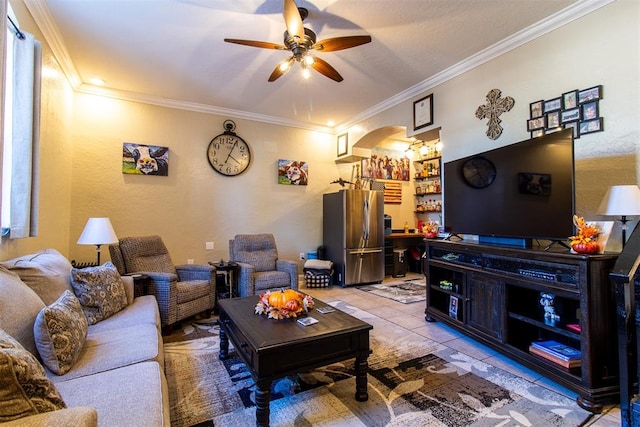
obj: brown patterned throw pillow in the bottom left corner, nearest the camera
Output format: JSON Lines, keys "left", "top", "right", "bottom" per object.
{"left": 0, "top": 329, "right": 66, "bottom": 422}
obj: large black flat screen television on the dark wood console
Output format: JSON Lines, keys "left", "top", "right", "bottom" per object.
{"left": 443, "top": 129, "right": 575, "bottom": 246}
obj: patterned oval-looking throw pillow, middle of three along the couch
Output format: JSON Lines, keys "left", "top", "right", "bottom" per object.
{"left": 33, "top": 291, "right": 88, "bottom": 375}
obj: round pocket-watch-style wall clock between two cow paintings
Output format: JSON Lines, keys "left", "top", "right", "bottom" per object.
{"left": 207, "top": 120, "right": 251, "bottom": 176}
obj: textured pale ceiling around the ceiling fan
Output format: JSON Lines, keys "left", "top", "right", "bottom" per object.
{"left": 18, "top": 0, "right": 581, "bottom": 129}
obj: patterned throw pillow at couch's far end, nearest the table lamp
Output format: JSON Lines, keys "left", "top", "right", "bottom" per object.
{"left": 71, "top": 262, "right": 127, "bottom": 325}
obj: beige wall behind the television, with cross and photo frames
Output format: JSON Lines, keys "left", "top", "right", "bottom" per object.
{"left": 342, "top": 0, "right": 640, "bottom": 249}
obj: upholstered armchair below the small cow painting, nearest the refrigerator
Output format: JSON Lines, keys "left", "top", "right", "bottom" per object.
{"left": 229, "top": 234, "right": 298, "bottom": 296}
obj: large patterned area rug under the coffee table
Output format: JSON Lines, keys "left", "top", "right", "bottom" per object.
{"left": 165, "top": 301, "right": 589, "bottom": 427}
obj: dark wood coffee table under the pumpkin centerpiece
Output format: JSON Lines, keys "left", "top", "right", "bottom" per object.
{"left": 218, "top": 296, "right": 373, "bottom": 426}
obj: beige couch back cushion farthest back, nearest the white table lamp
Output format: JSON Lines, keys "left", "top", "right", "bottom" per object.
{"left": 2, "top": 249, "right": 71, "bottom": 305}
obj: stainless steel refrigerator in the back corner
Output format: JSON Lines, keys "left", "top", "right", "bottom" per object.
{"left": 322, "top": 190, "right": 384, "bottom": 286}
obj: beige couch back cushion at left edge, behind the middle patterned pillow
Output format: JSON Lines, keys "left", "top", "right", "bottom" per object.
{"left": 0, "top": 265, "right": 44, "bottom": 355}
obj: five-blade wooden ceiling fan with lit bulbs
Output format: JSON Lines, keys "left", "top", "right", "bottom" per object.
{"left": 224, "top": 0, "right": 371, "bottom": 82}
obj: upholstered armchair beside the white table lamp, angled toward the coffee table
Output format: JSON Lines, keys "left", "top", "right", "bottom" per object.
{"left": 109, "top": 236, "right": 216, "bottom": 327}
